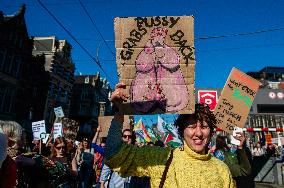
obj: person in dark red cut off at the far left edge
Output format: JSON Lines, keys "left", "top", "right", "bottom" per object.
{"left": 0, "top": 128, "right": 17, "bottom": 188}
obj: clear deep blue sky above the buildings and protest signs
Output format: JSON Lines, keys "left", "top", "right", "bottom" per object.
{"left": 0, "top": 0, "right": 284, "bottom": 88}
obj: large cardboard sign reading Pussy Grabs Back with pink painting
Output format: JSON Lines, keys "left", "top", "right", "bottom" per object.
{"left": 114, "top": 16, "right": 195, "bottom": 114}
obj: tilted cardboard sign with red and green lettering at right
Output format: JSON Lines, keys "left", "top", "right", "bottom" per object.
{"left": 214, "top": 68, "right": 260, "bottom": 134}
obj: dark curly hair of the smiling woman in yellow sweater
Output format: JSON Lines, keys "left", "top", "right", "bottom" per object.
{"left": 175, "top": 103, "right": 216, "bottom": 138}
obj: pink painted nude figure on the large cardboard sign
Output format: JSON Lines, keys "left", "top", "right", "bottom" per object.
{"left": 130, "top": 27, "right": 189, "bottom": 113}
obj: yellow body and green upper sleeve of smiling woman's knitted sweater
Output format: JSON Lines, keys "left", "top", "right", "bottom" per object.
{"left": 105, "top": 144, "right": 235, "bottom": 188}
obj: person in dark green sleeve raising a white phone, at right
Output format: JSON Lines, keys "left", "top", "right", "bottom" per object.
{"left": 214, "top": 133, "right": 253, "bottom": 188}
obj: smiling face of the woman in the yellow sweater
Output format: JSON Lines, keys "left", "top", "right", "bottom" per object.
{"left": 184, "top": 121, "right": 211, "bottom": 154}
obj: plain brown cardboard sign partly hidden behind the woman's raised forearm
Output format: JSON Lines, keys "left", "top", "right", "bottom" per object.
{"left": 99, "top": 116, "right": 133, "bottom": 138}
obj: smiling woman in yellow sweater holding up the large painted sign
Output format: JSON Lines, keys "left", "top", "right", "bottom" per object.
{"left": 105, "top": 83, "right": 235, "bottom": 188}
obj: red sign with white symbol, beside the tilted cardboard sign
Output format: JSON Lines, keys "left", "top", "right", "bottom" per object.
{"left": 198, "top": 90, "right": 218, "bottom": 111}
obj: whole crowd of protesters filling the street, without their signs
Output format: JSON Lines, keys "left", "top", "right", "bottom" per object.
{"left": 0, "top": 84, "right": 284, "bottom": 188}
